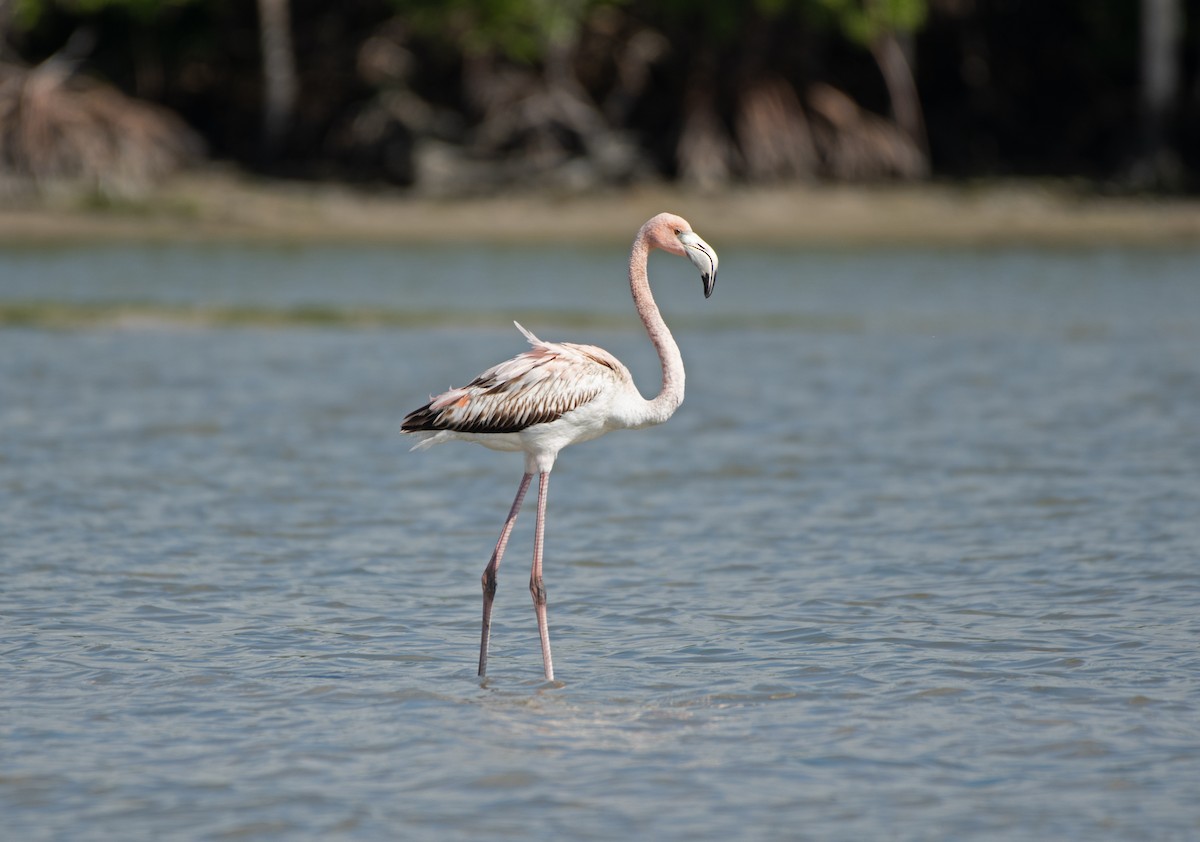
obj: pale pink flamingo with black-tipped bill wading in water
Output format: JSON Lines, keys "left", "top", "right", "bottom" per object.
{"left": 401, "top": 213, "right": 716, "bottom": 681}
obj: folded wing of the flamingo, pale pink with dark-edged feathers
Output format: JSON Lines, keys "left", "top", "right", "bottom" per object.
{"left": 401, "top": 323, "right": 629, "bottom": 433}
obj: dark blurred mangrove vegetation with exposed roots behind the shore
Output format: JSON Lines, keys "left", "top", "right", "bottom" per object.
{"left": 0, "top": 0, "right": 1200, "bottom": 194}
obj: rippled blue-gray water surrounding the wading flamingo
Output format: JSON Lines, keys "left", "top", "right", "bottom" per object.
{"left": 0, "top": 242, "right": 1200, "bottom": 841}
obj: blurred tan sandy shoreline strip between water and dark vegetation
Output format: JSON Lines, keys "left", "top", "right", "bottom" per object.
{"left": 0, "top": 170, "right": 1200, "bottom": 248}
